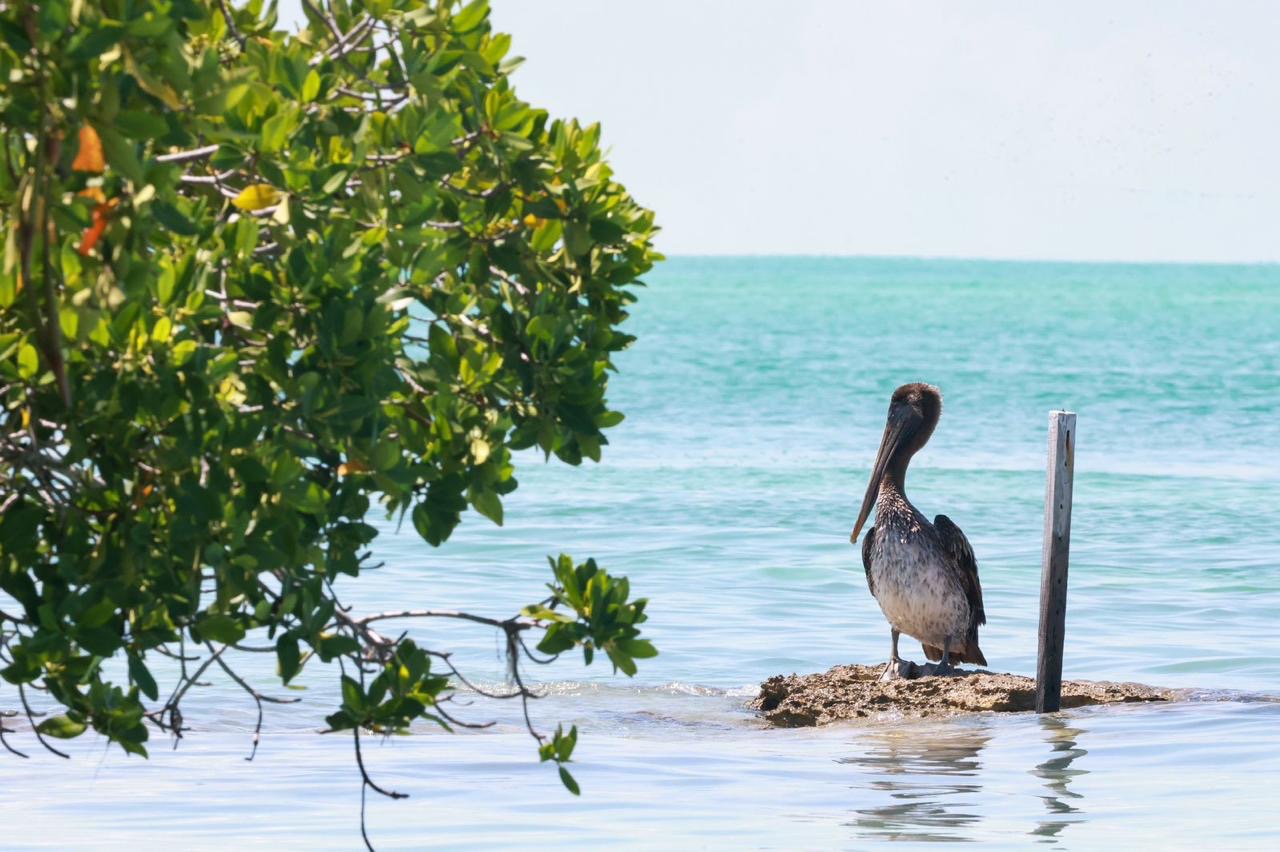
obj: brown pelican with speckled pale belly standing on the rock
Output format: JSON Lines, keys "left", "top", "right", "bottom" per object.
{"left": 849, "top": 383, "right": 987, "bottom": 679}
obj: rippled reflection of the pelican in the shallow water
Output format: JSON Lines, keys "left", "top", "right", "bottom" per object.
{"left": 840, "top": 725, "right": 991, "bottom": 842}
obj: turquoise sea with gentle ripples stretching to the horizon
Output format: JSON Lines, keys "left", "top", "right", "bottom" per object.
{"left": 0, "top": 257, "right": 1280, "bottom": 849}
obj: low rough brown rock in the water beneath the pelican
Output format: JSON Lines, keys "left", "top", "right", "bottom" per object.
{"left": 751, "top": 664, "right": 1174, "bottom": 728}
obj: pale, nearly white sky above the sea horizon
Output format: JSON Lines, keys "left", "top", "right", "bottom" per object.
{"left": 285, "top": 0, "right": 1280, "bottom": 261}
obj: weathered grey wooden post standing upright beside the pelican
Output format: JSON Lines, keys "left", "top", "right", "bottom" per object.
{"left": 1036, "top": 411, "right": 1075, "bottom": 713}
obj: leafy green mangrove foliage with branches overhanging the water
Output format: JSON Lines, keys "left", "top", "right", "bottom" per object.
{"left": 0, "top": 0, "right": 659, "bottom": 808}
